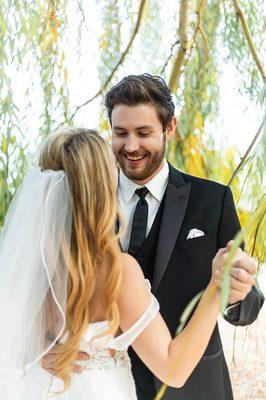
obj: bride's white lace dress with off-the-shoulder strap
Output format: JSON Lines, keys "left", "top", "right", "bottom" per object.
{"left": 44, "top": 281, "right": 159, "bottom": 400}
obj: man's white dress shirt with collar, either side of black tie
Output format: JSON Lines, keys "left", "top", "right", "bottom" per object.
{"left": 118, "top": 161, "right": 169, "bottom": 251}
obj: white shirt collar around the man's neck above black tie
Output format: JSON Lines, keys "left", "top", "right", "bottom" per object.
{"left": 119, "top": 160, "right": 169, "bottom": 204}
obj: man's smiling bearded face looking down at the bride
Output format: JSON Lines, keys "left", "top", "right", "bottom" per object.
{"left": 112, "top": 103, "right": 172, "bottom": 185}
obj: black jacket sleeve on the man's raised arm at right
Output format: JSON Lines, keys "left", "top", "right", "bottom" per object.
{"left": 217, "top": 187, "right": 264, "bottom": 326}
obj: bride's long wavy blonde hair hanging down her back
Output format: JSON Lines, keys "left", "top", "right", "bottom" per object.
{"left": 40, "top": 128, "right": 121, "bottom": 388}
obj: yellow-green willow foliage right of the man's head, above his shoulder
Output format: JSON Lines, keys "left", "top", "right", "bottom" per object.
{"left": 165, "top": 1, "right": 266, "bottom": 270}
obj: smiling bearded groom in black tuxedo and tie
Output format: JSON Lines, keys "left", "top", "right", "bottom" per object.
{"left": 106, "top": 74, "right": 264, "bottom": 400}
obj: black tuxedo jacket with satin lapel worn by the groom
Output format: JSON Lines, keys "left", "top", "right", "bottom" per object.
{"left": 131, "top": 165, "right": 264, "bottom": 400}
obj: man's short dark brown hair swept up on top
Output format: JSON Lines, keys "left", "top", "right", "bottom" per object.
{"left": 105, "top": 74, "right": 175, "bottom": 131}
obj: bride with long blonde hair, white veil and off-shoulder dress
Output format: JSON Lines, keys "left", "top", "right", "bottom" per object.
{"left": 0, "top": 129, "right": 235, "bottom": 400}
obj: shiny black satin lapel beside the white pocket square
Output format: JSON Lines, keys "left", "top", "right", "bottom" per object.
{"left": 152, "top": 167, "right": 191, "bottom": 293}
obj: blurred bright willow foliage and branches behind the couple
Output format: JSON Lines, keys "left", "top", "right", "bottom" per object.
{"left": 0, "top": 0, "right": 266, "bottom": 267}
